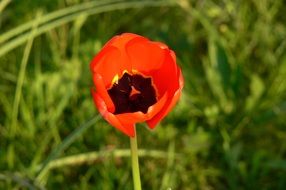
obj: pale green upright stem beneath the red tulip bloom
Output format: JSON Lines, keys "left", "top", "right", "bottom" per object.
{"left": 130, "top": 129, "right": 141, "bottom": 190}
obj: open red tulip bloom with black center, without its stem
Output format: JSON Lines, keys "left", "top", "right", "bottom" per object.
{"left": 90, "top": 33, "right": 184, "bottom": 137}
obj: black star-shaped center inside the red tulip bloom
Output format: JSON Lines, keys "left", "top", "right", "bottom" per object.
{"left": 108, "top": 73, "right": 157, "bottom": 114}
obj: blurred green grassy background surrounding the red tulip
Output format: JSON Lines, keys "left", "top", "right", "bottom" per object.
{"left": 0, "top": 0, "right": 286, "bottom": 190}
